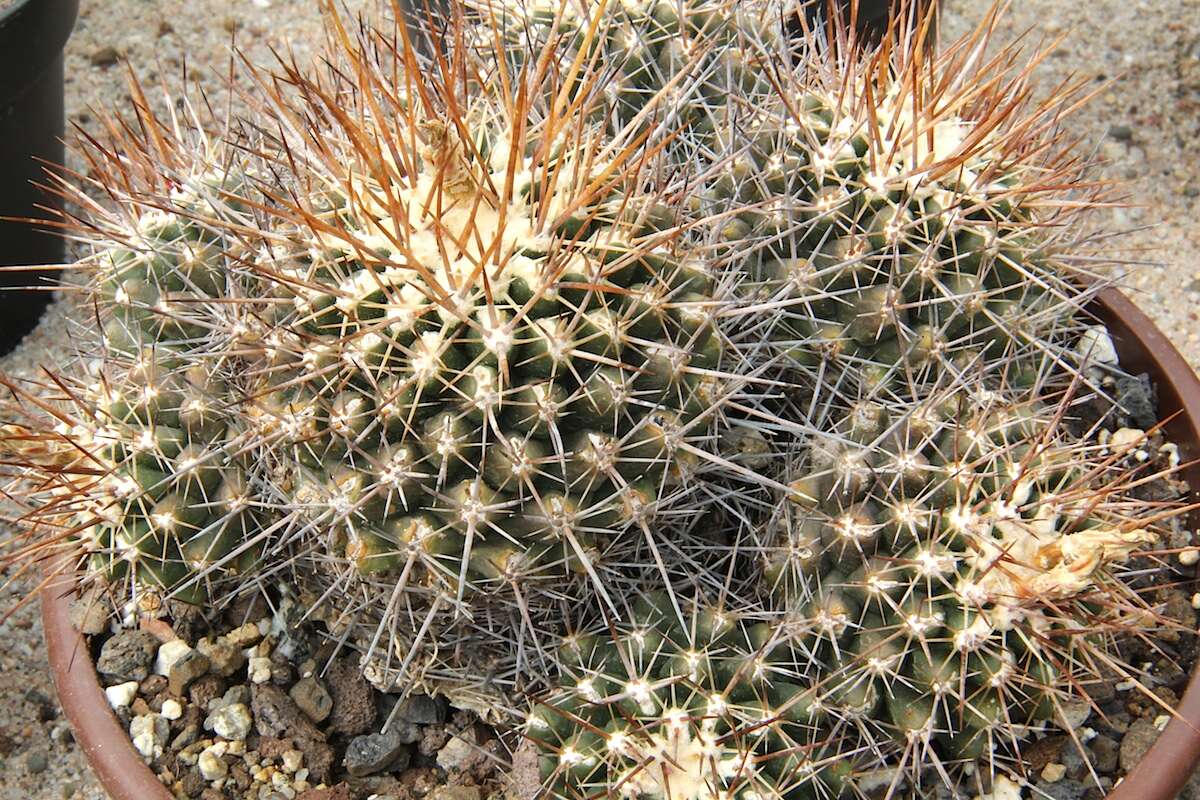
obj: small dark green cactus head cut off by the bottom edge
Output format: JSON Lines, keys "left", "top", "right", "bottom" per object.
{"left": 526, "top": 595, "right": 845, "bottom": 800}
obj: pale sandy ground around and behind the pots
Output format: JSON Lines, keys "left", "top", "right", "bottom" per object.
{"left": 0, "top": 0, "right": 1200, "bottom": 800}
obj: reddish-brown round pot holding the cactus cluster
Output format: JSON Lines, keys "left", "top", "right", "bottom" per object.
{"left": 42, "top": 289, "right": 1200, "bottom": 800}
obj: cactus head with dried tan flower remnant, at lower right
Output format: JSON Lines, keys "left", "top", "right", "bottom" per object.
{"left": 760, "top": 390, "right": 1156, "bottom": 786}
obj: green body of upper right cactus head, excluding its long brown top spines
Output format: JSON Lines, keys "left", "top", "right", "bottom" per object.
{"left": 708, "top": 83, "right": 1094, "bottom": 391}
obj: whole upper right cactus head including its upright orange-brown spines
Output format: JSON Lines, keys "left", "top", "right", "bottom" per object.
{"left": 708, "top": 7, "right": 1103, "bottom": 393}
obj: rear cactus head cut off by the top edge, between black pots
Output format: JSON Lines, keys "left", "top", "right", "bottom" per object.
{"left": 470, "top": 0, "right": 786, "bottom": 146}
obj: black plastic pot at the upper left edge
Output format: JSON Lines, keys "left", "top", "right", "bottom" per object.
{"left": 0, "top": 0, "right": 79, "bottom": 354}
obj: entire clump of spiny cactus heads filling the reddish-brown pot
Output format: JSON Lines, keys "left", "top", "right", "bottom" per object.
{"left": 6, "top": 0, "right": 1170, "bottom": 800}
